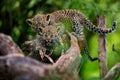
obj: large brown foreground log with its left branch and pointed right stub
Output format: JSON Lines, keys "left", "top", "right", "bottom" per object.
{"left": 0, "top": 34, "right": 81, "bottom": 80}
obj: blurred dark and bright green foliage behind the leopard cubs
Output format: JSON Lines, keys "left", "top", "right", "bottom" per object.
{"left": 0, "top": 0, "right": 120, "bottom": 80}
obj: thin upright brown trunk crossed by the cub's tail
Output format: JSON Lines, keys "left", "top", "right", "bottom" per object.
{"left": 98, "top": 16, "right": 108, "bottom": 79}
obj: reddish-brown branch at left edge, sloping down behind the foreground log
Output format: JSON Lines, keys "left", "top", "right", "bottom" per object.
{"left": 0, "top": 33, "right": 23, "bottom": 56}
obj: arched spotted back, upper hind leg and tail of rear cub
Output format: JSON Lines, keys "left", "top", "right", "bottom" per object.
{"left": 51, "top": 10, "right": 117, "bottom": 34}
